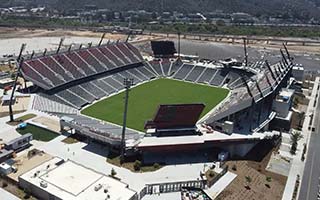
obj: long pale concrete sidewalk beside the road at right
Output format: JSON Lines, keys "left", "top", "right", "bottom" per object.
{"left": 282, "top": 77, "right": 320, "bottom": 200}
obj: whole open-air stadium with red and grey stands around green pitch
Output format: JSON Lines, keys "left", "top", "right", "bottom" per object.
{"left": 18, "top": 38, "right": 293, "bottom": 163}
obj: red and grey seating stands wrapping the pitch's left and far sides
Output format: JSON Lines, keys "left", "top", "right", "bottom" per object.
{"left": 25, "top": 40, "right": 272, "bottom": 114}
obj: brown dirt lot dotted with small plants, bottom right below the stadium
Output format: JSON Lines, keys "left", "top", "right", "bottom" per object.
{"left": 217, "top": 141, "right": 287, "bottom": 200}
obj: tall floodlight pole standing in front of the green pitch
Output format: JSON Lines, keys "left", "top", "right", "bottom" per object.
{"left": 120, "top": 78, "right": 133, "bottom": 164}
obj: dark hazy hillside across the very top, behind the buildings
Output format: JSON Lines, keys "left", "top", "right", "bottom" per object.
{"left": 0, "top": 0, "right": 320, "bottom": 18}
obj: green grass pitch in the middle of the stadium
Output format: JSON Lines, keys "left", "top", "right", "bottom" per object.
{"left": 81, "top": 79, "right": 229, "bottom": 131}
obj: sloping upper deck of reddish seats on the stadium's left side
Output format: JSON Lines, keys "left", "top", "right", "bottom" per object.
{"left": 21, "top": 43, "right": 143, "bottom": 90}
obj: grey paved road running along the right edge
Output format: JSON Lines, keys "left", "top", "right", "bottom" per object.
{"left": 299, "top": 93, "right": 320, "bottom": 200}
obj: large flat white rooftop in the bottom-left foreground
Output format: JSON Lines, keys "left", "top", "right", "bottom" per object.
{"left": 20, "top": 157, "right": 136, "bottom": 200}
